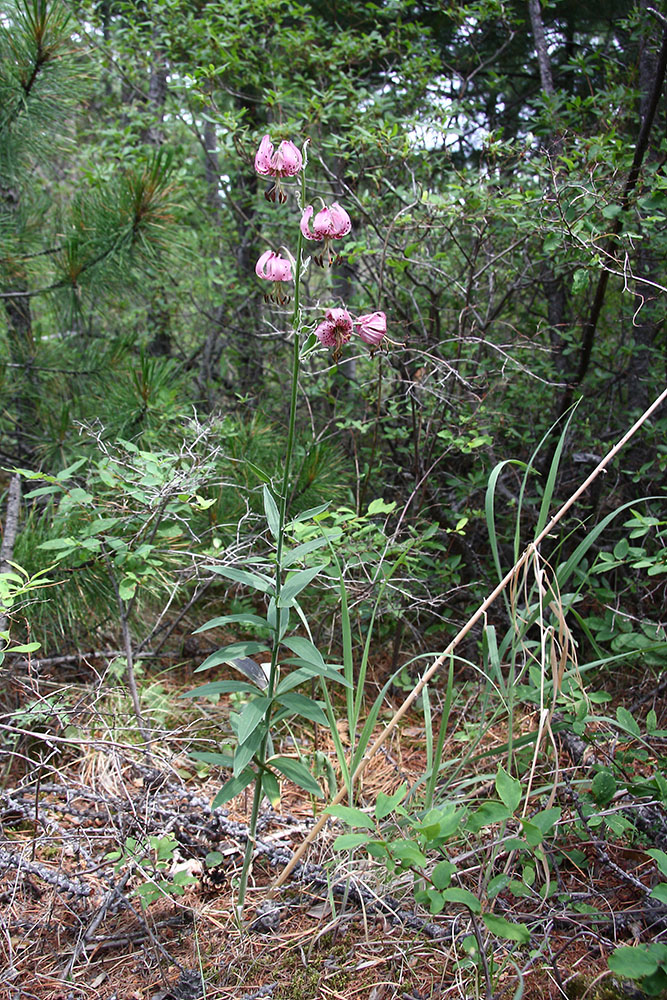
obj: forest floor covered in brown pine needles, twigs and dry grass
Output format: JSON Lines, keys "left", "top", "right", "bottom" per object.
{"left": 0, "top": 648, "right": 667, "bottom": 1000}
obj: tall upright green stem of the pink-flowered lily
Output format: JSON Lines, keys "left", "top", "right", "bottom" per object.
{"left": 236, "top": 171, "right": 306, "bottom": 920}
